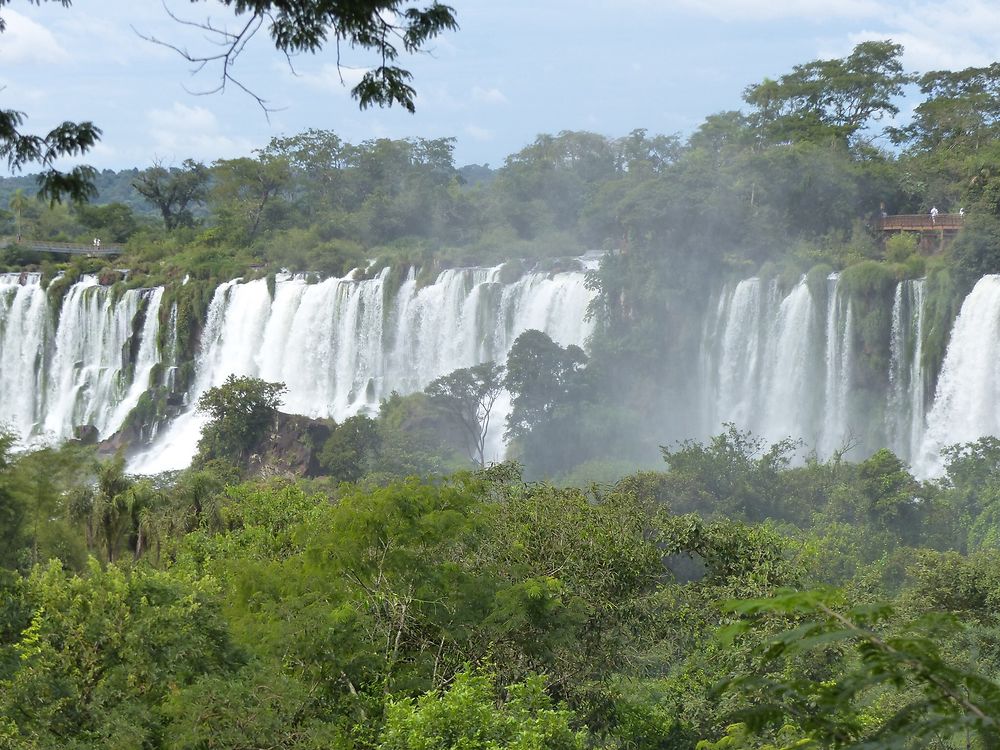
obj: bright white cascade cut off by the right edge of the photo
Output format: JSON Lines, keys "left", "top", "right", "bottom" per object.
{"left": 915, "top": 275, "right": 1000, "bottom": 476}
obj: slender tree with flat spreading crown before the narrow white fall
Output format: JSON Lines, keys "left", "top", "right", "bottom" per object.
{"left": 424, "top": 362, "right": 504, "bottom": 468}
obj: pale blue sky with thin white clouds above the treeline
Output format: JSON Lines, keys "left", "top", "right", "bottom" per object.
{"left": 0, "top": 0, "right": 1000, "bottom": 174}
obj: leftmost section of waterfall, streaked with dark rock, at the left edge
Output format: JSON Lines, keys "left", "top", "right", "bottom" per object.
{"left": 0, "top": 274, "right": 163, "bottom": 443}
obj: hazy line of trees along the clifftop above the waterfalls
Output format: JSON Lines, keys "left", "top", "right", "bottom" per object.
{"left": 0, "top": 41, "right": 1000, "bottom": 286}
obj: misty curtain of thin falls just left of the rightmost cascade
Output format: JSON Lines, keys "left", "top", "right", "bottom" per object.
{"left": 701, "top": 274, "right": 925, "bottom": 460}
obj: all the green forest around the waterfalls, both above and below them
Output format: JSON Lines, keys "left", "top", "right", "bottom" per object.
{"left": 0, "top": 41, "right": 1000, "bottom": 750}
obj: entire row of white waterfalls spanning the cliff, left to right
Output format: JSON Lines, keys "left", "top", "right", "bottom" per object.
{"left": 0, "top": 260, "right": 976, "bottom": 476}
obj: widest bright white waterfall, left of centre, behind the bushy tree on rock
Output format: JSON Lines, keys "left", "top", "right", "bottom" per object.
{"left": 132, "top": 266, "right": 591, "bottom": 473}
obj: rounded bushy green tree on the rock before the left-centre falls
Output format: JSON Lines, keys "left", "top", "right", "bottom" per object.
{"left": 198, "top": 375, "right": 286, "bottom": 463}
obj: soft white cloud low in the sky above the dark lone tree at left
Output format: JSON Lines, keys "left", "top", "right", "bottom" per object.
{"left": 146, "top": 102, "right": 258, "bottom": 164}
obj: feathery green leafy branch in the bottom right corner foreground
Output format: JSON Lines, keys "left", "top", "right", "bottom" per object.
{"left": 717, "top": 590, "right": 1000, "bottom": 750}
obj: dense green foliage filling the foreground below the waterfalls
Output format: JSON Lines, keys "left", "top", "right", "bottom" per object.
{"left": 9, "top": 432, "right": 1000, "bottom": 750}
